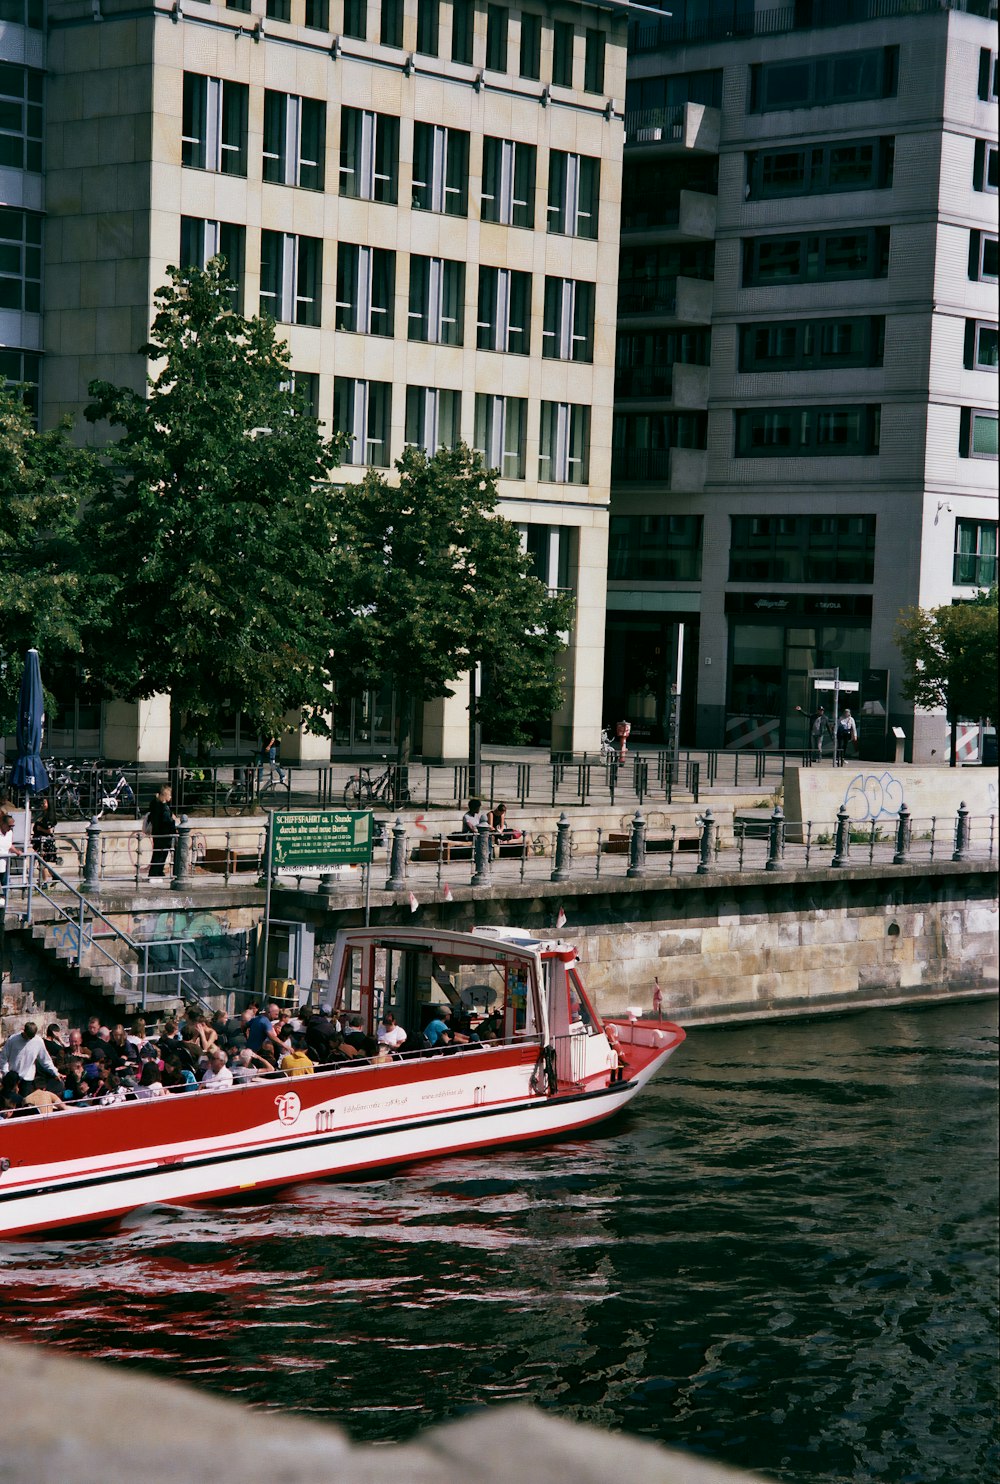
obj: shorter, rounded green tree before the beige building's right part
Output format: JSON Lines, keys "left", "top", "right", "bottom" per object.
{"left": 329, "top": 445, "right": 573, "bottom": 760}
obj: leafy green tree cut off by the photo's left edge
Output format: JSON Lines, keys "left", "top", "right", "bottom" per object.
{"left": 0, "top": 387, "right": 108, "bottom": 732}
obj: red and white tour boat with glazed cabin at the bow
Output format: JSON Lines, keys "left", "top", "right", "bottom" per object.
{"left": 0, "top": 928, "right": 684, "bottom": 1236}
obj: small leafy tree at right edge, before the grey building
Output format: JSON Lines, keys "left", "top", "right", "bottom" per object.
{"left": 895, "top": 588, "right": 997, "bottom": 767}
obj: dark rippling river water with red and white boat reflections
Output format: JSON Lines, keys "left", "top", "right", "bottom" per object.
{"left": 0, "top": 1002, "right": 1000, "bottom": 1484}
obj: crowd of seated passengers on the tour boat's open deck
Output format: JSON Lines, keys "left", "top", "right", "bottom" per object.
{"left": 0, "top": 1003, "right": 504, "bottom": 1117}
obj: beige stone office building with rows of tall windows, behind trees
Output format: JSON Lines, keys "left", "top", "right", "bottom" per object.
{"left": 0, "top": 0, "right": 628, "bottom": 761}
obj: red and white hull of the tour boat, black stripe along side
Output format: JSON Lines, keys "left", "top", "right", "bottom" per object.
{"left": 0, "top": 1022, "right": 684, "bottom": 1236}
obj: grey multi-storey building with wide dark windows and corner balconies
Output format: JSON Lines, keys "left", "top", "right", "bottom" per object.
{"left": 605, "top": 0, "right": 997, "bottom": 760}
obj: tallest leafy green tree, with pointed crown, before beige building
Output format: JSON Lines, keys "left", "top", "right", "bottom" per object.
{"left": 86, "top": 258, "right": 341, "bottom": 763}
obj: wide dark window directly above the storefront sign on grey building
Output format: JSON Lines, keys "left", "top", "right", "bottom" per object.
{"left": 728, "top": 515, "right": 875, "bottom": 583}
